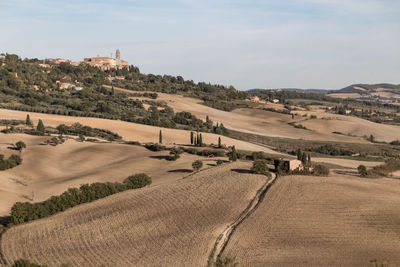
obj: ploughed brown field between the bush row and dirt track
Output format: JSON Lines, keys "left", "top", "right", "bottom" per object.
{"left": 0, "top": 162, "right": 266, "bottom": 266}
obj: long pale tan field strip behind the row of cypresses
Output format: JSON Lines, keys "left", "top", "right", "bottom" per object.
{"left": 0, "top": 109, "right": 279, "bottom": 154}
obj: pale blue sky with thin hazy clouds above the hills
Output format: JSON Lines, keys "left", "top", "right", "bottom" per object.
{"left": 0, "top": 0, "right": 400, "bottom": 90}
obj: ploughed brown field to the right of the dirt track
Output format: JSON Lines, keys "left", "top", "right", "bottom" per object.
{"left": 223, "top": 175, "right": 400, "bottom": 266}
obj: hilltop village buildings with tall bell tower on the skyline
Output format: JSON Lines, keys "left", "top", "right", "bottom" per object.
{"left": 52, "top": 49, "right": 129, "bottom": 70}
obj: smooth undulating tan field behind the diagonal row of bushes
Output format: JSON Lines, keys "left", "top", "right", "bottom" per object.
{"left": 0, "top": 134, "right": 220, "bottom": 216}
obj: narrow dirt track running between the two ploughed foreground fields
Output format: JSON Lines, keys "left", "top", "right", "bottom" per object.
{"left": 207, "top": 174, "right": 278, "bottom": 267}
